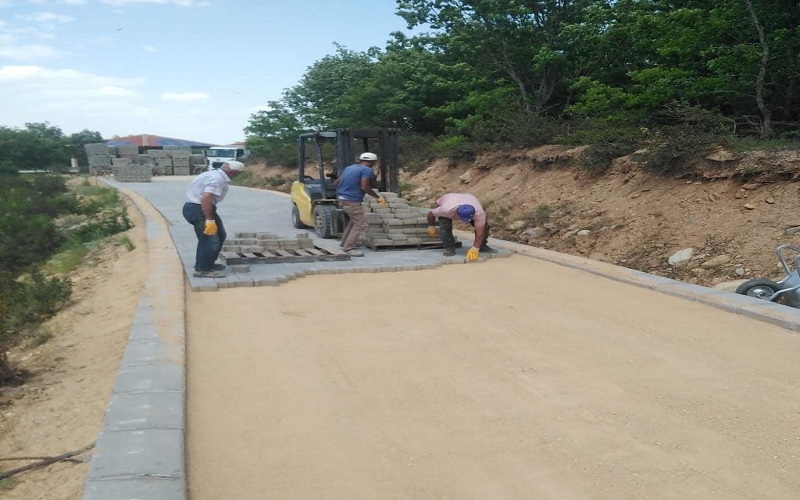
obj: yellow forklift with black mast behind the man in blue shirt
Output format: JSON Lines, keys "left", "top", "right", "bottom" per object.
{"left": 292, "top": 128, "right": 400, "bottom": 238}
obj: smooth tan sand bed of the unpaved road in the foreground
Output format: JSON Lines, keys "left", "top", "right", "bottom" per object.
{"left": 187, "top": 256, "right": 800, "bottom": 500}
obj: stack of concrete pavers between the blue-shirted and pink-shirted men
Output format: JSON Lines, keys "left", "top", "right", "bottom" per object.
{"left": 363, "top": 193, "right": 441, "bottom": 250}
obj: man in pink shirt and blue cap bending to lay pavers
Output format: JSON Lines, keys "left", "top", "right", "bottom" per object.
{"left": 427, "top": 193, "right": 496, "bottom": 260}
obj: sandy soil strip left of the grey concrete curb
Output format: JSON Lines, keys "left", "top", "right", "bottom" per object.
{"left": 0, "top": 193, "right": 148, "bottom": 500}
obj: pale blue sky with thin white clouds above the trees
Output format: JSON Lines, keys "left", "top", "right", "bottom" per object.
{"left": 0, "top": 0, "right": 406, "bottom": 144}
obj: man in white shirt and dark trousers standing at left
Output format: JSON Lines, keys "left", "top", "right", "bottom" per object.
{"left": 183, "top": 161, "right": 245, "bottom": 278}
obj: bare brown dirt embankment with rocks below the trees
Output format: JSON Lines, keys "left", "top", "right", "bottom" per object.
{"left": 247, "top": 146, "right": 800, "bottom": 286}
